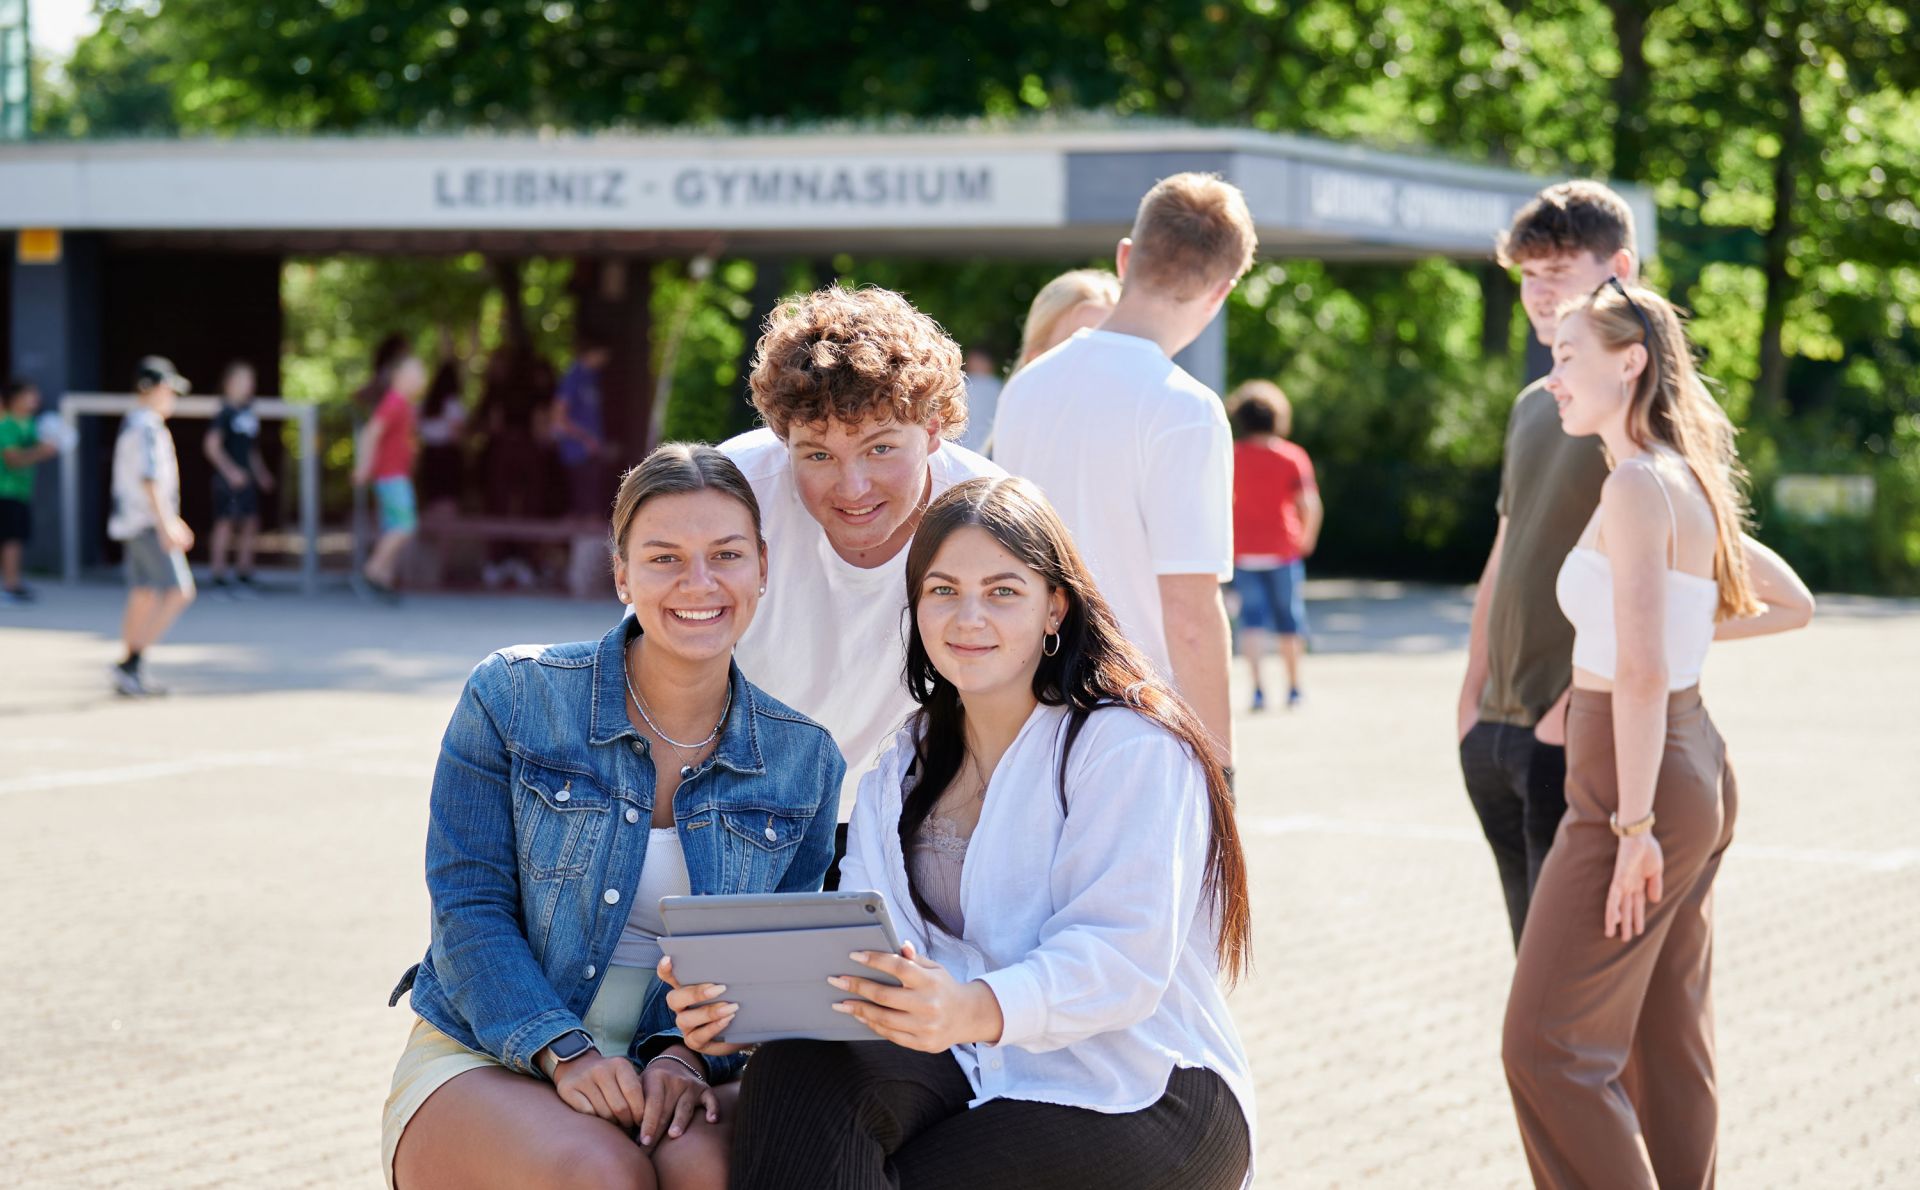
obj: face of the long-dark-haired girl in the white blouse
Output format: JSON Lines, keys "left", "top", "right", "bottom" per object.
{"left": 914, "top": 526, "right": 1068, "bottom": 699}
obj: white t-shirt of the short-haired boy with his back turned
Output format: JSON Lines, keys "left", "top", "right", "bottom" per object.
{"left": 993, "top": 330, "right": 1233, "bottom": 679}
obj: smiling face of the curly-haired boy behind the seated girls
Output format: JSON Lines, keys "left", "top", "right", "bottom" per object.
{"left": 787, "top": 417, "right": 941, "bottom": 566}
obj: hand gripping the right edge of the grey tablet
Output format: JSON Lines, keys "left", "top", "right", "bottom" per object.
{"left": 828, "top": 942, "right": 1004, "bottom": 1054}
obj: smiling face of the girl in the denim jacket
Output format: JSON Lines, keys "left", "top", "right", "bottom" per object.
{"left": 614, "top": 489, "right": 766, "bottom": 660}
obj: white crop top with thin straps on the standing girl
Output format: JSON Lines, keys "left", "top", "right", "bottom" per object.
{"left": 1553, "top": 466, "right": 1720, "bottom": 691}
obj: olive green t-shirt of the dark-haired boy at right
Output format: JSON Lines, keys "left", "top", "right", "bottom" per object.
{"left": 1480, "top": 382, "right": 1607, "bottom": 727}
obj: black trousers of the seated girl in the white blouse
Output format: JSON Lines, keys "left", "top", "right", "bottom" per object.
{"left": 730, "top": 1040, "right": 1250, "bottom": 1190}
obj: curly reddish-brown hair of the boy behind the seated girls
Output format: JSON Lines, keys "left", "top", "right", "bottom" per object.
{"left": 749, "top": 284, "right": 966, "bottom": 441}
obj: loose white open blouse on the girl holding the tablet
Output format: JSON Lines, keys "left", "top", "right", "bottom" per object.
{"left": 839, "top": 706, "right": 1258, "bottom": 1174}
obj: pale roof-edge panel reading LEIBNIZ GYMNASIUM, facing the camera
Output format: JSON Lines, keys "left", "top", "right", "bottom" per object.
{"left": 0, "top": 144, "right": 1066, "bottom": 230}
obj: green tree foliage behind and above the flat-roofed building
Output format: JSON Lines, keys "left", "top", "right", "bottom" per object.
{"left": 40, "top": 0, "right": 1920, "bottom": 585}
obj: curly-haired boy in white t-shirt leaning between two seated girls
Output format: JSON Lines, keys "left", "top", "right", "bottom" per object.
{"left": 720, "top": 286, "right": 1002, "bottom": 821}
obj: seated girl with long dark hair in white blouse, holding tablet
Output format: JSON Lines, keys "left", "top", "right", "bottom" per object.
{"left": 662, "top": 478, "right": 1254, "bottom": 1190}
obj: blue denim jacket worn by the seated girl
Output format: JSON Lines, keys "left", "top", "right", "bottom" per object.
{"left": 392, "top": 618, "right": 847, "bottom": 1081}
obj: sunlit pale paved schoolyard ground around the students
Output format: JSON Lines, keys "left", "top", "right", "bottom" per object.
{"left": 0, "top": 585, "right": 1920, "bottom": 1188}
